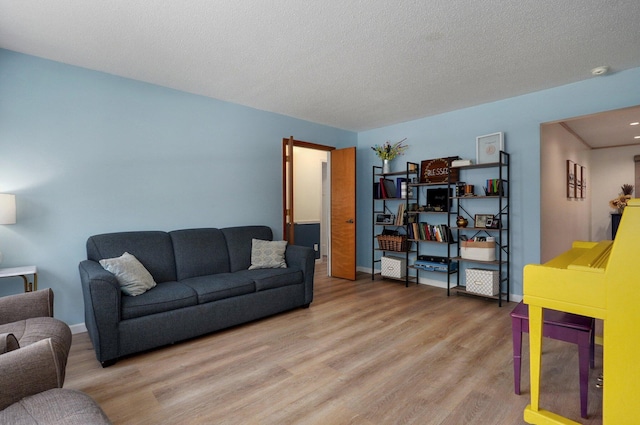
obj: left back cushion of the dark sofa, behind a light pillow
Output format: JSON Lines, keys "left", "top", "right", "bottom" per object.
{"left": 87, "top": 231, "right": 176, "bottom": 283}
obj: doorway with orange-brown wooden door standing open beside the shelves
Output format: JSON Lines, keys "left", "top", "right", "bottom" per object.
{"left": 282, "top": 137, "right": 356, "bottom": 280}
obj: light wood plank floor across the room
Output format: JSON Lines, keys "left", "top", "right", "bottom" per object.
{"left": 65, "top": 266, "right": 602, "bottom": 425}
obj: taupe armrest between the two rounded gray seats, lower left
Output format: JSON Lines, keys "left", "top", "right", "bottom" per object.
{"left": 0, "top": 338, "right": 62, "bottom": 410}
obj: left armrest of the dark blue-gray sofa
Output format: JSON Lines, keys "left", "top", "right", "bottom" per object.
{"left": 78, "top": 260, "right": 122, "bottom": 362}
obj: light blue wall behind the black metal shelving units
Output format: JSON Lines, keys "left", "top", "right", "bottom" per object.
{"left": 358, "top": 68, "right": 640, "bottom": 295}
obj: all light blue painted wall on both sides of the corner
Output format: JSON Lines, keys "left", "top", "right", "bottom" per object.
{"left": 0, "top": 49, "right": 640, "bottom": 324}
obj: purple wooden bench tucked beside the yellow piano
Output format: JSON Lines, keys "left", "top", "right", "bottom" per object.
{"left": 511, "top": 302, "right": 595, "bottom": 418}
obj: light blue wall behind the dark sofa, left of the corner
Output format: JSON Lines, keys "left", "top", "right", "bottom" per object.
{"left": 0, "top": 50, "right": 357, "bottom": 324}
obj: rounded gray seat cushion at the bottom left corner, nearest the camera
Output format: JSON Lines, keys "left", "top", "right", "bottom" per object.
{"left": 0, "top": 388, "right": 111, "bottom": 425}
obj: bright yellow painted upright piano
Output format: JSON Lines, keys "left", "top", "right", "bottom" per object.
{"left": 524, "top": 199, "right": 640, "bottom": 425}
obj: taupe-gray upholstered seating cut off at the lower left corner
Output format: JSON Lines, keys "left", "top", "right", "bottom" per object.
{"left": 0, "top": 289, "right": 111, "bottom": 425}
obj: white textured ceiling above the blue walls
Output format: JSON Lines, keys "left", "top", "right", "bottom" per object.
{"left": 0, "top": 0, "right": 640, "bottom": 131}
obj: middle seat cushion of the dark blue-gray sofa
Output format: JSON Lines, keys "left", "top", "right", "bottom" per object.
{"left": 181, "top": 273, "right": 256, "bottom": 304}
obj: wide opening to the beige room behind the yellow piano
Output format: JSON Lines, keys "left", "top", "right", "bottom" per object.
{"left": 540, "top": 106, "right": 640, "bottom": 262}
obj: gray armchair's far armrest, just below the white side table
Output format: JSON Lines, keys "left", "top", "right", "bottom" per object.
{"left": 0, "top": 288, "right": 53, "bottom": 325}
